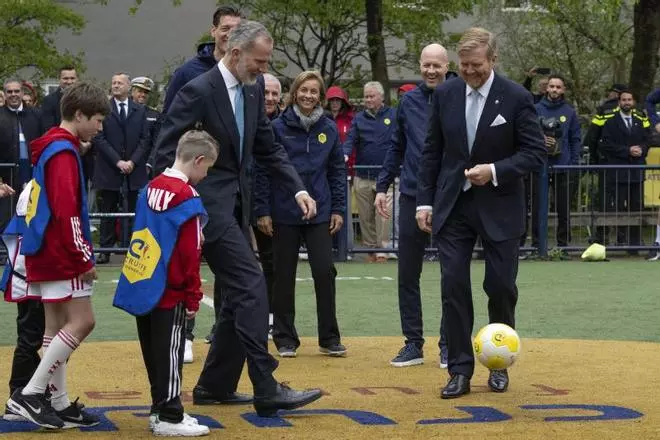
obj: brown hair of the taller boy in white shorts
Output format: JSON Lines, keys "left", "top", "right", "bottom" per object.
{"left": 60, "top": 81, "right": 110, "bottom": 121}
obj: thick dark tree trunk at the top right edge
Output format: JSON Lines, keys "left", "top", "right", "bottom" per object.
{"left": 629, "top": 0, "right": 660, "bottom": 101}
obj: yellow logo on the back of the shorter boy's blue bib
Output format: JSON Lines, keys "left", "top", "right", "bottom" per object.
{"left": 121, "top": 228, "right": 161, "bottom": 284}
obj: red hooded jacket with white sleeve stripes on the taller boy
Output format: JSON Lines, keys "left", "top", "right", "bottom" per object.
{"left": 25, "top": 127, "right": 94, "bottom": 282}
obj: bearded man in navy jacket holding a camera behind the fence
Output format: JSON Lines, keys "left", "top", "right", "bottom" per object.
{"left": 532, "top": 74, "right": 581, "bottom": 254}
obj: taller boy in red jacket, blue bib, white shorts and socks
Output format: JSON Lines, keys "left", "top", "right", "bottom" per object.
{"left": 7, "top": 82, "right": 110, "bottom": 429}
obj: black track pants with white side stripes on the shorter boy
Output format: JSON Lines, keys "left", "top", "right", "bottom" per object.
{"left": 136, "top": 303, "right": 186, "bottom": 423}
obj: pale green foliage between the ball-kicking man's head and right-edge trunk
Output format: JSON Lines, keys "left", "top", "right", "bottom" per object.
{"left": 480, "top": 0, "right": 633, "bottom": 112}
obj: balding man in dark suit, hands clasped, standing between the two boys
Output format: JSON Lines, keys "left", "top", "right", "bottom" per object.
{"left": 93, "top": 73, "right": 149, "bottom": 264}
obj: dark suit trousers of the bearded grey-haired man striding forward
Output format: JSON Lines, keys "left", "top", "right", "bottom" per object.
{"left": 197, "top": 218, "right": 278, "bottom": 395}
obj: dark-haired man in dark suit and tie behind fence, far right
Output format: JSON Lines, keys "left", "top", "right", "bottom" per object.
{"left": 598, "top": 90, "right": 652, "bottom": 249}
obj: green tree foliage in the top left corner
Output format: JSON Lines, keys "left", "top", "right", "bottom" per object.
{"left": 0, "top": 0, "right": 85, "bottom": 78}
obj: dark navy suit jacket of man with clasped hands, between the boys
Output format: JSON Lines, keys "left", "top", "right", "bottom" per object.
{"left": 92, "top": 99, "right": 150, "bottom": 191}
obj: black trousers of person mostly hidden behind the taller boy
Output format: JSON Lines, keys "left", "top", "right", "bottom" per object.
{"left": 9, "top": 299, "right": 45, "bottom": 395}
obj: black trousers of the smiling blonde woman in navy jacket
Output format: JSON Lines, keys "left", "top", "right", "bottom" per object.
{"left": 273, "top": 222, "right": 341, "bottom": 348}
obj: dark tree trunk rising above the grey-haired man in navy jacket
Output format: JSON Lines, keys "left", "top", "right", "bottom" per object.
{"left": 365, "top": 0, "right": 390, "bottom": 105}
